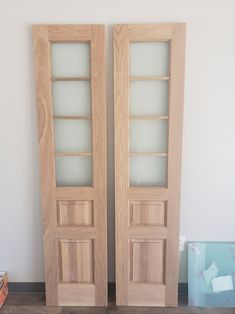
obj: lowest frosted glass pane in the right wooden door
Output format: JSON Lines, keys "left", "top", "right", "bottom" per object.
{"left": 129, "top": 156, "right": 167, "bottom": 186}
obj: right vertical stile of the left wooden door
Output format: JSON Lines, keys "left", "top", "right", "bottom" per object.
{"left": 91, "top": 25, "right": 108, "bottom": 306}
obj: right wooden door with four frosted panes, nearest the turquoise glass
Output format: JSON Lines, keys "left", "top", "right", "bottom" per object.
{"left": 113, "top": 24, "right": 185, "bottom": 306}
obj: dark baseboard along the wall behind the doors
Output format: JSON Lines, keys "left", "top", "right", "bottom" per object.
{"left": 8, "top": 282, "right": 188, "bottom": 295}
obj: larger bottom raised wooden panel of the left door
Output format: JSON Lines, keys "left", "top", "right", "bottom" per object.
{"left": 59, "top": 239, "right": 93, "bottom": 283}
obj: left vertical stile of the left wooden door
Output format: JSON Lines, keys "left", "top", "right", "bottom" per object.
{"left": 33, "top": 26, "right": 58, "bottom": 305}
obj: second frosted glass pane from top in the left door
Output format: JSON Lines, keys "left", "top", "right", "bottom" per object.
{"left": 52, "top": 81, "right": 91, "bottom": 116}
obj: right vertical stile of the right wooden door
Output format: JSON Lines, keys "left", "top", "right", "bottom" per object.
{"left": 166, "top": 24, "right": 186, "bottom": 306}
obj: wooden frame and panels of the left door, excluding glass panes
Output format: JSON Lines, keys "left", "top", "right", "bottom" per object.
{"left": 34, "top": 25, "right": 107, "bottom": 306}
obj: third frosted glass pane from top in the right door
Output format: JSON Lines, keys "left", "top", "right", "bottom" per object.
{"left": 129, "top": 120, "right": 168, "bottom": 153}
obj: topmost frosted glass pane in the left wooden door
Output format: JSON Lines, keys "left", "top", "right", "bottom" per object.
{"left": 51, "top": 43, "right": 90, "bottom": 77}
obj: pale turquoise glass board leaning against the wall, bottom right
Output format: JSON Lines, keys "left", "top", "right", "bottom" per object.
{"left": 188, "top": 242, "right": 235, "bottom": 306}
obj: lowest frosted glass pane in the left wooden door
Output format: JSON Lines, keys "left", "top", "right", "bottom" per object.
{"left": 55, "top": 156, "right": 92, "bottom": 186}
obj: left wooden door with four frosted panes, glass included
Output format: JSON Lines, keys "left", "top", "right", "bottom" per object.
{"left": 33, "top": 25, "right": 107, "bottom": 306}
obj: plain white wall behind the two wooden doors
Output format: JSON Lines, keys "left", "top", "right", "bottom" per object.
{"left": 0, "top": 0, "right": 235, "bottom": 282}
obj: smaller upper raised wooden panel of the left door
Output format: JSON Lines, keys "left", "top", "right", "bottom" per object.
{"left": 57, "top": 201, "right": 93, "bottom": 226}
